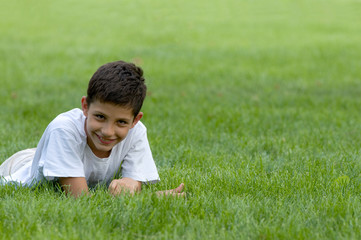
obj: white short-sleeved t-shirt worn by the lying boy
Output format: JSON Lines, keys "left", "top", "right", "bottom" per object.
{"left": 4, "top": 108, "right": 159, "bottom": 187}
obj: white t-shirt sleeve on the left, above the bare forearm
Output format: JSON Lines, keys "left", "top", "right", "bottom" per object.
{"left": 41, "top": 128, "right": 85, "bottom": 180}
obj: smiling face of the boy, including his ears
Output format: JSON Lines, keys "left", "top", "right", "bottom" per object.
{"left": 81, "top": 97, "right": 143, "bottom": 158}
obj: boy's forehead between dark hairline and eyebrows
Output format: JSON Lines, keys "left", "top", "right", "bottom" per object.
{"left": 89, "top": 100, "right": 133, "bottom": 119}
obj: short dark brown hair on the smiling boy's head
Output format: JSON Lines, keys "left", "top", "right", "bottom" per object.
{"left": 86, "top": 61, "right": 147, "bottom": 116}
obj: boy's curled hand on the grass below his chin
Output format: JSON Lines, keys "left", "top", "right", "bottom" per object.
{"left": 108, "top": 178, "right": 142, "bottom": 196}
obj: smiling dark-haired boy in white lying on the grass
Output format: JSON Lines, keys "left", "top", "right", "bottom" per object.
{"left": 0, "top": 61, "right": 184, "bottom": 197}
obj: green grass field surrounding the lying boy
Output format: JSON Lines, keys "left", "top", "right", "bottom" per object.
{"left": 0, "top": 0, "right": 361, "bottom": 239}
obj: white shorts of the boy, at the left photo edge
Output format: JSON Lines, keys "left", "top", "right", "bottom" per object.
{"left": 0, "top": 148, "right": 36, "bottom": 177}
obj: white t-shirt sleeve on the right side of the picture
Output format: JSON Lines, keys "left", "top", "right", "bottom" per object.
{"left": 121, "top": 127, "right": 159, "bottom": 183}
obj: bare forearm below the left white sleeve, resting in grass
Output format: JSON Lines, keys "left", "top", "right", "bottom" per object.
{"left": 59, "top": 177, "right": 89, "bottom": 198}
